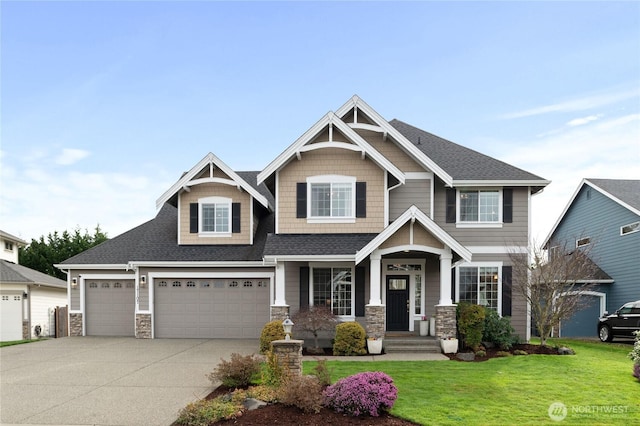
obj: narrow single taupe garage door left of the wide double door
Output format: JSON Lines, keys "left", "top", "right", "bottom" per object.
{"left": 85, "top": 280, "right": 135, "bottom": 336}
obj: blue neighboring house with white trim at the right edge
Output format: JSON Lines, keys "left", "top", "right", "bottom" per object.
{"left": 544, "top": 179, "right": 640, "bottom": 337}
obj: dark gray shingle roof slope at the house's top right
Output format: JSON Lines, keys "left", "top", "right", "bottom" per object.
{"left": 389, "top": 119, "right": 544, "bottom": 181}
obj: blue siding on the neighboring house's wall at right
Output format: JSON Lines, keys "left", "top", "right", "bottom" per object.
{"left": 551, "top": 186, "right": 640, "bottom": 312}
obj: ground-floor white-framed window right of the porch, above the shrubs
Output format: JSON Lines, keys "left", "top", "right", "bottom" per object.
{"left": 458, "top": 266, "right": 499, "bottom": 311}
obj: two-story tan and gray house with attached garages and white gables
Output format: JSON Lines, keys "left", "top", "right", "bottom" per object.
{"left": 58, "top": 96, "right": 549, "bottom": 339}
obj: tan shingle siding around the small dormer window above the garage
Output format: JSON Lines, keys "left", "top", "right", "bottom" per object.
{"left": 179, "top": 183, "right": 251, "bottom": 244}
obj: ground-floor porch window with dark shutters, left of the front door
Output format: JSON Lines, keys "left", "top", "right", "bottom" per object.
{"left": 312, "top": 268, "right": 354, "bottom": 316}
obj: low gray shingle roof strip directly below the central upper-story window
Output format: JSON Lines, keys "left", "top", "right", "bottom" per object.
{"left": 264, "top": 234, "right": 378, "bottom": 256}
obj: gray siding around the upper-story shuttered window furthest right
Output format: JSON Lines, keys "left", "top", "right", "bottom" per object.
{"left": 433, "top": 182, "right": 529, "bottom": 246}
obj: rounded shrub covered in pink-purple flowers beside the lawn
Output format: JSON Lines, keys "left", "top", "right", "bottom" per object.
{"left": 323, "top": 372, "right": 398, "bottom": 417}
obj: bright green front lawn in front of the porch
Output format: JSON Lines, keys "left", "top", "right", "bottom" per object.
{"left": 304, "top": 340, "right": 640, "bottom": 425}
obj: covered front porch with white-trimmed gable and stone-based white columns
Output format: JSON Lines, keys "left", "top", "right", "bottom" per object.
{"left": 271, "top": 207, "right": 471, "bottom": 338}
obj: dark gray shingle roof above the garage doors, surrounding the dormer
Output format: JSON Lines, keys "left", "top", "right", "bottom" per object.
{"left": 62, "top": 203, "right": 274, "bottom": 265}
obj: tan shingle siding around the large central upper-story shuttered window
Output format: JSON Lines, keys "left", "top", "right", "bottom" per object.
{"left": 277, "top": 148, "right": 384, "bottom": 234}
